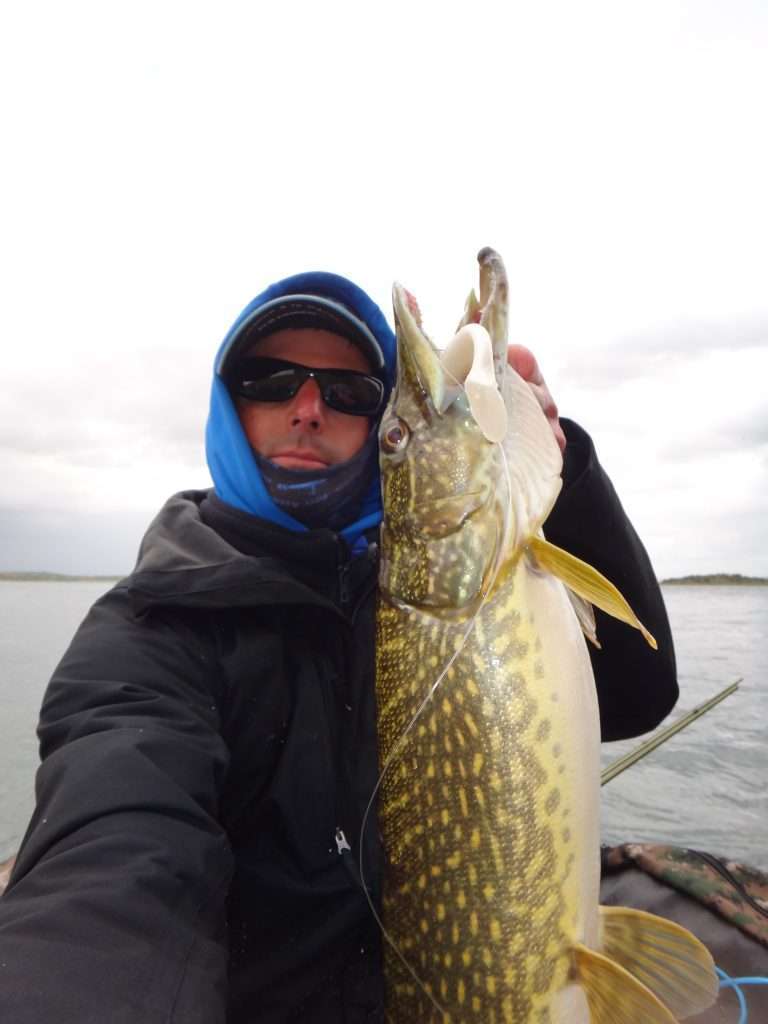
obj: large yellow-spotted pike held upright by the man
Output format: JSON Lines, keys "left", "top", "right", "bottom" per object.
{"left": 377, "top": 249, "right": 718, "bottom": 1024}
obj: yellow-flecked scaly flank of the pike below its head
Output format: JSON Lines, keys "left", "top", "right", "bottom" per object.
{"left": 377, "top": 561, "right": 572, "bottom": 1022}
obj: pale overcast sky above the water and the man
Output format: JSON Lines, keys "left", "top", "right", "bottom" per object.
{"left": 0, "top": 0, "right": 768, "bottom": 577}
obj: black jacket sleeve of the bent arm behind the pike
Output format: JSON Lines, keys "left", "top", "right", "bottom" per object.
{"left": 544, "top": 420, "right": 678, "bottom": 739}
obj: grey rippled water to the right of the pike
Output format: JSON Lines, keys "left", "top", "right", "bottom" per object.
{"left": 602, "top": 586, "right": 768, "bottom": 869}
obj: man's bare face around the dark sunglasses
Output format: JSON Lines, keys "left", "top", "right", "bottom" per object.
{"left": 236, "top": 328, "right": 372, "bottom": 469}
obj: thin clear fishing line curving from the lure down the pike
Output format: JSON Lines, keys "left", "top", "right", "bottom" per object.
{"left": 358, "top": 368, "right": 512, "bottom": 1016}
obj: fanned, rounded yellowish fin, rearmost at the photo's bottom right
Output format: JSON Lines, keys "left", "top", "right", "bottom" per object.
{"left": 600, "top": 906, "right": 718, "bottom": 1019}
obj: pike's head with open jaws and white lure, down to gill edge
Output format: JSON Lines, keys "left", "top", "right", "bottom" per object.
{"left": 379, "top": 285, "right": 508, "bottom": 611}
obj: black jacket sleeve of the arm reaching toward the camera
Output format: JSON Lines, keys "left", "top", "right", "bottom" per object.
{"left": 0, "top": 587, "right": 231, "bottom": 1024}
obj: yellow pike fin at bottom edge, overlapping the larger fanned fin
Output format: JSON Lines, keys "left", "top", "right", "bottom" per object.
{"left": 573, "top": 945, "right": 677, "bottom": 1024}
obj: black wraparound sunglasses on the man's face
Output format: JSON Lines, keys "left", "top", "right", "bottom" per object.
{"left": 226, "top": 355, "right": 384, "bottom": 416}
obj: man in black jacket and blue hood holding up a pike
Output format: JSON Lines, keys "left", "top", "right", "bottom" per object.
{"left": 0, "top": 273, "right": 677, "bottom": 1024}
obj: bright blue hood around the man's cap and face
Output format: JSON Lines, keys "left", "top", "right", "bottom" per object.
{"left": 206, "top": 271, "right": 396, "bottom": 546}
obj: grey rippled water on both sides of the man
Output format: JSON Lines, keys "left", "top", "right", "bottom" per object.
{"left": 0, "top": 581, "right": 768, "bottom": 868}
